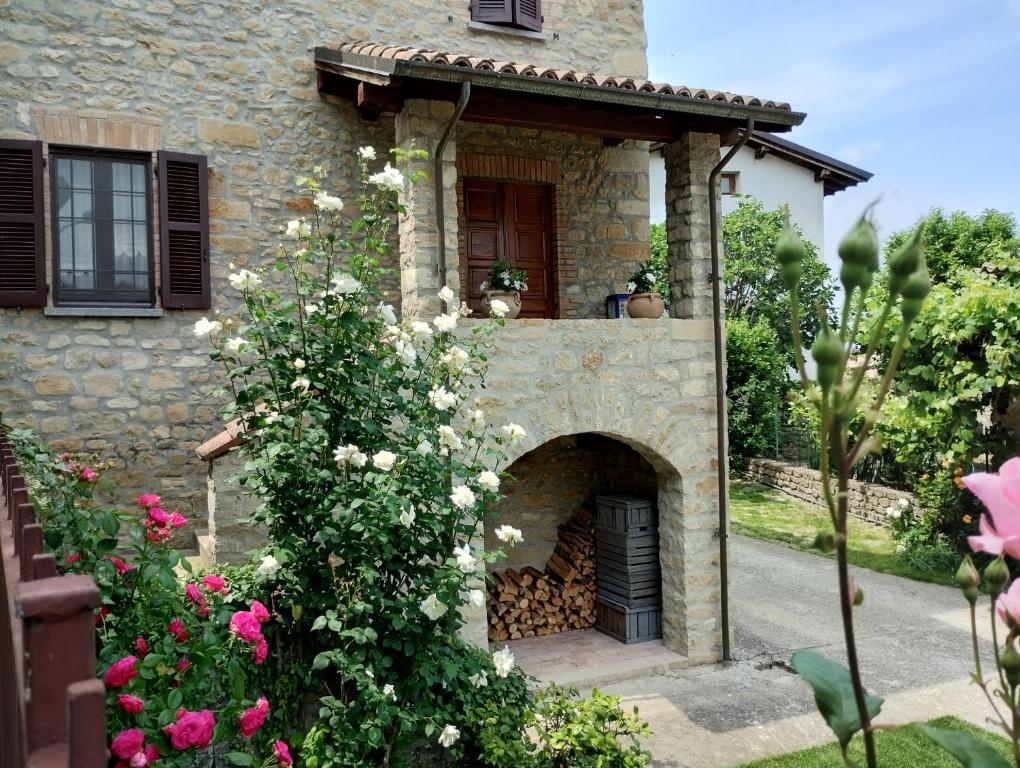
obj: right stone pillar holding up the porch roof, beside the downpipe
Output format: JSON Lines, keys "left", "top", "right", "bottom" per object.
{"left": 663, "top": 134, "right": 722, "bottom": 319}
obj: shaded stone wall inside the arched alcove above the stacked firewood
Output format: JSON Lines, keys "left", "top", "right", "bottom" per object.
{"left": 486, "top": 434, "right": 657, "bottom": 570}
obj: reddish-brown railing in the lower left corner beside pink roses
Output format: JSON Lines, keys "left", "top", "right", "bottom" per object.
{"left": 0, "top": 427, "right": 107, "bottom": 768}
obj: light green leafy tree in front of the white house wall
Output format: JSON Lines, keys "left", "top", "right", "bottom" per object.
{"left": 722, "top": 198, "right": 834, "bottom": 352}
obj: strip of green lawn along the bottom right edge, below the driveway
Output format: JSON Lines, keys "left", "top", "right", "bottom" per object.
{"left": 741, "top": 717, "right": 1012, "bottom": 768}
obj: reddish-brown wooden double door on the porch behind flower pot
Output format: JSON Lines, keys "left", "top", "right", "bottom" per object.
{"left": 464, "top": 178, "right": 554, "bottom": 317}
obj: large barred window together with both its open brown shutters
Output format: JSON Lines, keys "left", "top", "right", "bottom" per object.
{"left": 0, "top": 139, "right": 211, "bottom": 315}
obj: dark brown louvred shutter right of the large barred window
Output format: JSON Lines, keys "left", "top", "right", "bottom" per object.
{"left": 157, "top": 152, "right": 210, "bottom": 309}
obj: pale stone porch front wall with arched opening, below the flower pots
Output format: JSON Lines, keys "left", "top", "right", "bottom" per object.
{"left": 478, "top": 319, "right": 722, "bottom": 663}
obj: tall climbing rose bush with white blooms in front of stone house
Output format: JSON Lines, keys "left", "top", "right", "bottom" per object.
{"left": 195, "top": 147, "right": 538, "bottom": 766}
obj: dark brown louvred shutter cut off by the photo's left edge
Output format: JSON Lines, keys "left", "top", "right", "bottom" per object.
{"left": 0, "top": 141, "right": 46, "bottom": 307}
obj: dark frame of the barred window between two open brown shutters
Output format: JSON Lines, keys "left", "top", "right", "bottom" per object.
{"left": 46, "top": 145, "right": 157, "bottom": 309}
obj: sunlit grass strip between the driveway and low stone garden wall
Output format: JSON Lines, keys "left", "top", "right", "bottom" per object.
{"left": 729, "top": 477, "right": 955, "bottom": 586}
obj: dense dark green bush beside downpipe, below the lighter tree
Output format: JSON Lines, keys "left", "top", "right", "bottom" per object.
{"left": 726, "top": 318, "right": 789, "bottom": 466}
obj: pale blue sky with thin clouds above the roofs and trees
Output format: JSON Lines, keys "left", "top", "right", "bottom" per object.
{"left": 645, "top": 0, "right": 1020, "bottom": 264}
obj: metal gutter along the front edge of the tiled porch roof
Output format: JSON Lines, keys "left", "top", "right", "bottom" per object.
{"left": 315, "top": 47, "right": 806, "bottom": 130}
